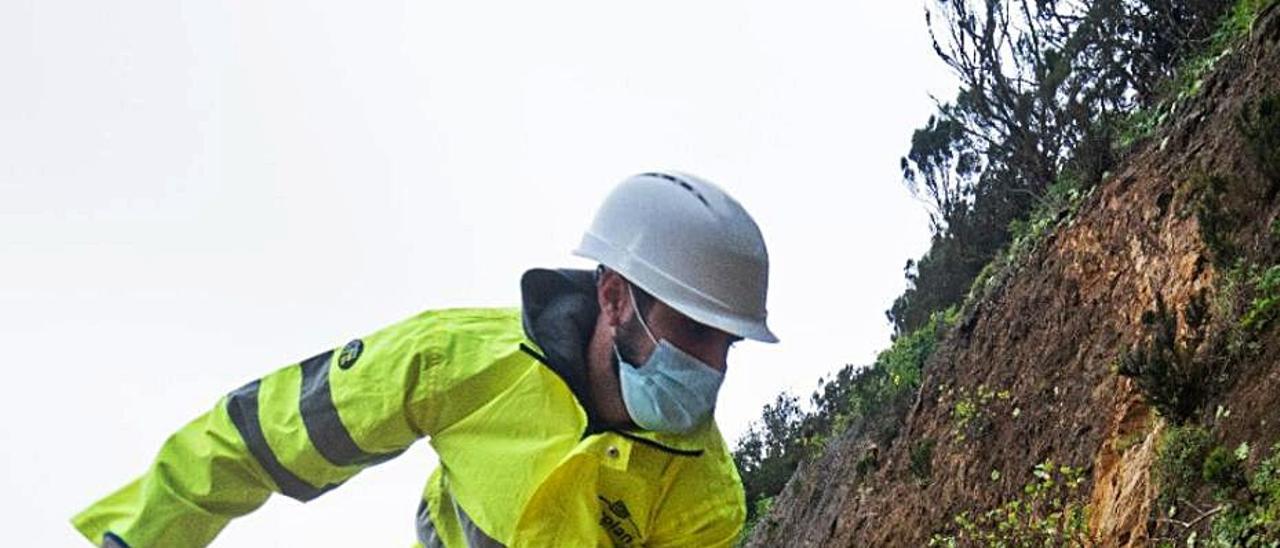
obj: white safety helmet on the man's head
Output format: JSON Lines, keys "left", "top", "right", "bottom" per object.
{"left": 573, "top": 172, "right": 778, "bottom": 342}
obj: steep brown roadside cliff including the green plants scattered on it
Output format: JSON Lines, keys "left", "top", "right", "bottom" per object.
{"left": 748, "top": 9, "right": 1280, "bottom": 547}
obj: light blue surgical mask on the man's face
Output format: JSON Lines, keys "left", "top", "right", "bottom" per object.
{"left": 613, "top": 286, "right": 724, "bottom": 434}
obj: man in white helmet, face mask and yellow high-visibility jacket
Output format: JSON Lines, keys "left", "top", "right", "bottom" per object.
{"left": 72, "top": 173, "right": 777, "bottom": 548}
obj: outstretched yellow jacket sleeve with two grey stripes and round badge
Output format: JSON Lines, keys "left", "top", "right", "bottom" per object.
{"left": 72, "top": 312, "right": 471, "bottom": 548}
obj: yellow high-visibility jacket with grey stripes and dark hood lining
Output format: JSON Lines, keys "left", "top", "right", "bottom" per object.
{"left": 72, "top": 269, "right": 746, "bottom": 548}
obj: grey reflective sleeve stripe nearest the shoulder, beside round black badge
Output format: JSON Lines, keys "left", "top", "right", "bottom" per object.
{"left": 298, "top": 351, "right": 403, "bottom": 466}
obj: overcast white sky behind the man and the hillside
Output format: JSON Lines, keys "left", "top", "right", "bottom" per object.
{"left": 0, "top": 0, "right": 954, "bottom": 547}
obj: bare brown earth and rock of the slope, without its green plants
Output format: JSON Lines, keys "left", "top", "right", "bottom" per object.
{"left": 749, "top": 9, "right": 1280, "bottom": 547}
